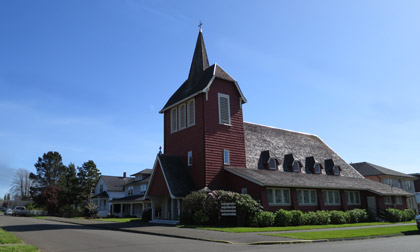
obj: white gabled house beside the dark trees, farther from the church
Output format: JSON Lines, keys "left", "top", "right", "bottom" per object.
{"left": 92, "top": 172, "right": 134, "bottom": 217}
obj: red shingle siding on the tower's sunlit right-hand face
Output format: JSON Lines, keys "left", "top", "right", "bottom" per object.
{"left": 204, "top": 78, "right": 246, "bottom": 189}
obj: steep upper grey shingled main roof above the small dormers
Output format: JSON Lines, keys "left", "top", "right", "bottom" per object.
{"left": 244, "top": 122, "right": 363, "bottom": 178}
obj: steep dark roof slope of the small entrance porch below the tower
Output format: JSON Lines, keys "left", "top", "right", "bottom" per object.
{"left": 158, "top": 154, "right": 196, "bottom": 198}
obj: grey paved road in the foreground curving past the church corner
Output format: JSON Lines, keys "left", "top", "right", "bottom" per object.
{"left": 0, "top": 216, "right": 420, "bottom": 252}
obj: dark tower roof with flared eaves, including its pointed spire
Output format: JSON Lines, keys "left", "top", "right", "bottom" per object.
{"left": 160, "top": 30, "right": 246, "bottom": 113}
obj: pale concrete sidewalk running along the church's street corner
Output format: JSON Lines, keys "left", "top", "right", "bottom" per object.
{"left": 41, "top": 217, "right": 415, "bottom": 244}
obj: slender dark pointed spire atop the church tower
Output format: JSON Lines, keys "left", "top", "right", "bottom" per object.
{"left": 188, "top": 29, "right": 209, "bottom": 84}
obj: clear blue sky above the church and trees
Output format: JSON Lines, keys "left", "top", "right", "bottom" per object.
{"left": 0, "top": 0, "right": 420, "bottom": 196}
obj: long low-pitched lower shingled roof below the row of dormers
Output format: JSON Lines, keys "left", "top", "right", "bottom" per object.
{"left": 224, "top": 167, "right": 412, "bottom": 196}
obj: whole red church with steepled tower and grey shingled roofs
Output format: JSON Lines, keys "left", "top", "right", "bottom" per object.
{"left": 145, "top": 30, "right": 411, "bottom": 223}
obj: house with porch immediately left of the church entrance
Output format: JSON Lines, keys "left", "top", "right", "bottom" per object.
{"left": 111, "top": 169, "right": 152, "bottom": 217}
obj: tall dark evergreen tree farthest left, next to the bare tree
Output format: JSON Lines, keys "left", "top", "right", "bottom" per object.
{"left": 30, "top": 151, "right": 66, "bottom": 215}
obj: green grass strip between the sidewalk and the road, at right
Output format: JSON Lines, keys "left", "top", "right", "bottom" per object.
{"left": 263, "top": 225, "right": 420, "bottom": 240}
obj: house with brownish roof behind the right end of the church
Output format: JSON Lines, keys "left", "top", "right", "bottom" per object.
{"left": 350, "top": 162, "right": 418, "bottom": 211}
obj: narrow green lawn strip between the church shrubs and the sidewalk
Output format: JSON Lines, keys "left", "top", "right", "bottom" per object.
{"left": 178, "top": 221, "right": 415, "bottom": 233}
